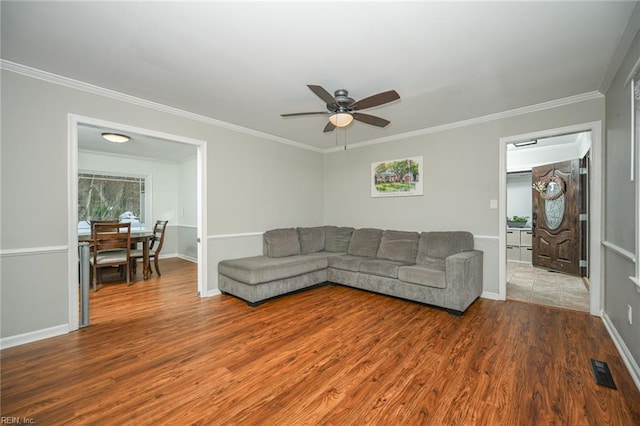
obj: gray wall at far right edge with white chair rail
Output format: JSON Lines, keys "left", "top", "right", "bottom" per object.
{"left": 604, "top": 27, "right": 640, "bottom": 372}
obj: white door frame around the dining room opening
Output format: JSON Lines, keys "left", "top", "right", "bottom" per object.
{"left": 67, "top": 114, "right": 208, "bottom": 331}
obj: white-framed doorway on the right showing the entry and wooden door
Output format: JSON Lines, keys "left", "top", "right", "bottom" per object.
{"left": 499, "top": 122, "right": 602, "bottom": 315}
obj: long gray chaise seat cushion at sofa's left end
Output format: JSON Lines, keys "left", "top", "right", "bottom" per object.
{"left": 218, "top": 253, "right": 327, "bottom": 284}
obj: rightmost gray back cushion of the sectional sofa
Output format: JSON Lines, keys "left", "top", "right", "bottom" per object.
{"left": 416, "top": 231, "right": 473, "bottom": 266}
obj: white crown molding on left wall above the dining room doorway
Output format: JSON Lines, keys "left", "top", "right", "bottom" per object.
{"left": 0, "top": 59, "right": 323, "bottom": 153}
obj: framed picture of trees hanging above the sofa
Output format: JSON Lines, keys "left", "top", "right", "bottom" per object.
{"left": 371, "top": 157, "right": 423, "bottom": 197}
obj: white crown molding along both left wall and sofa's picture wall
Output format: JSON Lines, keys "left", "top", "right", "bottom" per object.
{"left": 0, "top": 58, "right": 604, "bottom": 154}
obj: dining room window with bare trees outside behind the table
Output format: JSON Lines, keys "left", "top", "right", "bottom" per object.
{"left": 78, "top": 173, "right": 146, "bottom": 233}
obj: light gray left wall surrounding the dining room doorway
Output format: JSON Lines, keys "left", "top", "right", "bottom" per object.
{"left": 0, "top": 70, "right": 324, "bottom": 339}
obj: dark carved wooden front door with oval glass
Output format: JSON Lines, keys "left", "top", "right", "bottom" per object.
{"left": 531, "top": 160, "right": 582, "bottom": 276}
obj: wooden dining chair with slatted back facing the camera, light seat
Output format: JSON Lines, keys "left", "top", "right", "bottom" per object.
{"left": 90, "top": 222, "right": 131, "bottom": 291}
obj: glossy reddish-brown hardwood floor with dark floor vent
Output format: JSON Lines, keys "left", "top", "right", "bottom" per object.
{"left": 0, "top": 259, "right": 640, "bottom": 425}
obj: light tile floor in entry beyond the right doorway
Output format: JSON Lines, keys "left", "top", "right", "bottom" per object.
{"left": 507, "top": 262, "right": 589, "bottom": 312}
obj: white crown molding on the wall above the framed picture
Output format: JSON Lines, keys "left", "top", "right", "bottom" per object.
{"left": 324, "top": 91, "right": 604, "bottom": 154}
